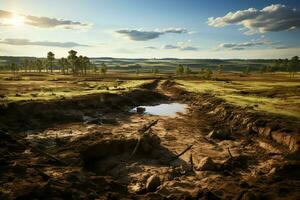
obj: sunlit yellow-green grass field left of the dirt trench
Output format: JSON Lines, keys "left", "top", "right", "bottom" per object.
{"left": 0, "top": 73, "right": 151, "bottom": 102}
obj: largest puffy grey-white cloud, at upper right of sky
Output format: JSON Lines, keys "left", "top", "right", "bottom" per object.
{"left": 208, "top": 4, "right": 300, "bottom": 35}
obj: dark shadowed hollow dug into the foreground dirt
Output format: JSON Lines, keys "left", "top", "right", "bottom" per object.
{"left": 80, "top": 133, "right": 186, "bottom": 178}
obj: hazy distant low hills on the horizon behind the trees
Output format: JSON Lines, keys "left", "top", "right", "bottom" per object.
{"left": 0, "top": 56, "right": 274, "bottom": 71}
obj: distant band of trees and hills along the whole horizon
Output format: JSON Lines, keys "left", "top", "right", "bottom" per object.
{"left": 0, "top": 54, "right": 300, "bottom": 75}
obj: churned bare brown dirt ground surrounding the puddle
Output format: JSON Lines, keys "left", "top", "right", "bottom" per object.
{"left": 0, "top": 81, "right": 300, "bottom": 199}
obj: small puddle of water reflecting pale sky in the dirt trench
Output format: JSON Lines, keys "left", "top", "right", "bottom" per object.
{"left": 130, "top": 103, "right": 188, "bottom": 116}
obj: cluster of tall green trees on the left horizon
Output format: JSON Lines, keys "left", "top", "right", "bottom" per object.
{"left": 5, "top": 50, "right": 108, "bottom": 75}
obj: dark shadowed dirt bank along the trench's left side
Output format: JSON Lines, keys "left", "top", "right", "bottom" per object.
{"left": 0, "top": 81, "right": 167, "bottom": 132}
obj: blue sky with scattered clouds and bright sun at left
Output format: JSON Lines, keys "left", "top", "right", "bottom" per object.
{"left": 0, "top": 0, "right": 300, "bottom": 59}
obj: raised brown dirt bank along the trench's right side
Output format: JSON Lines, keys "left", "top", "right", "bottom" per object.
{"left": 162, "top": 81, "right": 300, "bottom": 159}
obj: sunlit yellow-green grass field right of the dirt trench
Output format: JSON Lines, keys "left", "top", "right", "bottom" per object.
{"left": 177, "top": 77, "right": 300, "bottom": 118}
